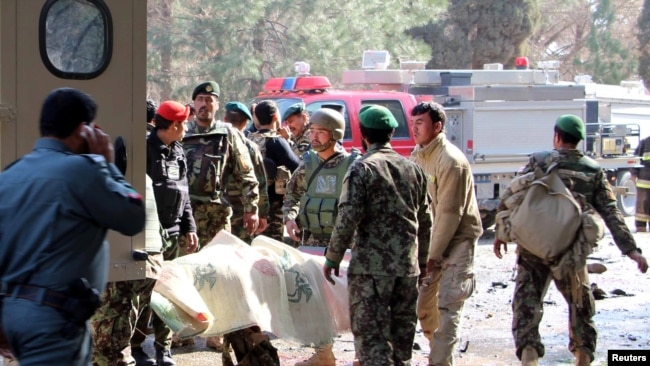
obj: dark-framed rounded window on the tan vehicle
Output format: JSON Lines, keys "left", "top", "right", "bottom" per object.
{"left": 38, "top": 0, "right": 113, "bottom": 79}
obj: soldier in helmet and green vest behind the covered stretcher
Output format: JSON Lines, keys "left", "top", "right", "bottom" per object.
{"left": 282, "top": 108, "right": 360, "bottom": 247}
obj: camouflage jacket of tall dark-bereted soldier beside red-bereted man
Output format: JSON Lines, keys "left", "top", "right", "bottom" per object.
{"left": 183, "top": 121, "right": 259, "bottom": 213}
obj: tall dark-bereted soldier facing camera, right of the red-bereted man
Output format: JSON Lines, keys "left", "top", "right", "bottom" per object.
{"left": 183, "top": 81, "right": 259, "bottom": 245}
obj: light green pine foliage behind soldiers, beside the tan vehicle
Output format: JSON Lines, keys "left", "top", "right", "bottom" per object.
{"left": 148, "top": 0, "right": 441, "bottom": 103}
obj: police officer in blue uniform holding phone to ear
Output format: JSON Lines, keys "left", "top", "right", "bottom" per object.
{"left": 0, "top": 88, "right": 145, "bottom": 366}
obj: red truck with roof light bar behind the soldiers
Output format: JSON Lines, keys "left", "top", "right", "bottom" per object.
{"left": 255, "top": 76, "right": 417, "bottom": 156}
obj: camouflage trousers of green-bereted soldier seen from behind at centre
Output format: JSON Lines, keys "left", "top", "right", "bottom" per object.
{"left": 348, "top": 274, "right": 418, "bottom": 366}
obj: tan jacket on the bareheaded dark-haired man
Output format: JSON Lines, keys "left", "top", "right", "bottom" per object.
{"left": 411, "top": 133, "right": 483, "bottom": 260}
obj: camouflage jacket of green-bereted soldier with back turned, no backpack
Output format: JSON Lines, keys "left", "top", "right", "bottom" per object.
{"left": 326, "top": 144, "right": 432, "bottom": 277}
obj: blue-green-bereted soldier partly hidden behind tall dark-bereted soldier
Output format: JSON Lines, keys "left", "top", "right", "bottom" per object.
{"left": 224, "top": 102, "right": 269, "bottom": 244}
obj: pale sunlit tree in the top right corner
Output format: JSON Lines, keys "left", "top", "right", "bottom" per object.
{"left": 528, "top": 0, "right": 642, "bottom": 84}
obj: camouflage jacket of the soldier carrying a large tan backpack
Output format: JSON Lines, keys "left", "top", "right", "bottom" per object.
{"left": 497, "top": 149, "right": 637, "bottom": 254}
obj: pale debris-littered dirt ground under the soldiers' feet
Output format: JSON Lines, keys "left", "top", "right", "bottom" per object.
{"left": 0, "top": 219, "right": 650, "bottom": 366}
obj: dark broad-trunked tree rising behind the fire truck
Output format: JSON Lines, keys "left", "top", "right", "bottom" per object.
{"left": 410, "top": 0, "right": 540, "bottom": 69}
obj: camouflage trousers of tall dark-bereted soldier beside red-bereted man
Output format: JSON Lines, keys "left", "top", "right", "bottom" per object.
{"left": 189, "top": 201, "right": 232, "bottom": 250}
